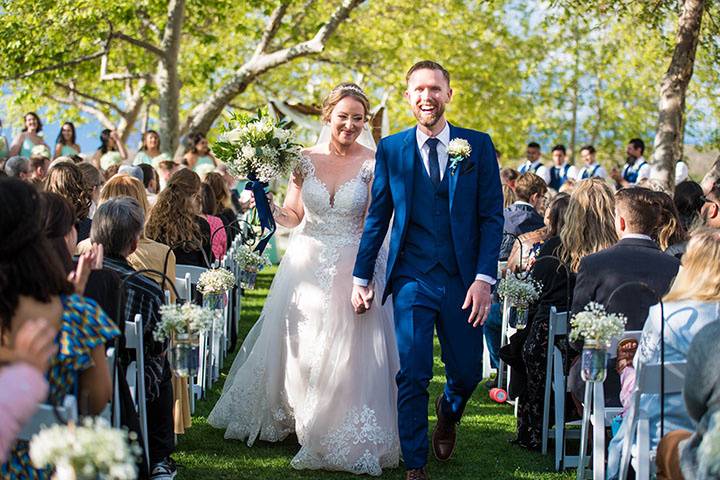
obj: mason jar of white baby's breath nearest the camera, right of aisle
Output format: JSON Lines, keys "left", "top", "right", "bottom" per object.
{"left": 570, "top": 302, "right": 627, "bottom": 382}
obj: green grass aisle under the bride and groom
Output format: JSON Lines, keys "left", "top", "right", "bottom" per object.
{"left": 174, "top": 269, "right": 573, "bottom": 480}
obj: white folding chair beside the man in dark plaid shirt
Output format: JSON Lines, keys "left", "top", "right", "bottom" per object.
{"left": 125, "top": 314, "right": 150, "bottom": 465}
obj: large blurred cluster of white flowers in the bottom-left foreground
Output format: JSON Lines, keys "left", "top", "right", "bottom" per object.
{"left": 30, "top": 418, "right": 142, "bottom": 480}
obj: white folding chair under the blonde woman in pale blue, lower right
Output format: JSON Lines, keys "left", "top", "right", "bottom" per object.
{"left": 620, "top": 362, "right": 687, "bottom": 480}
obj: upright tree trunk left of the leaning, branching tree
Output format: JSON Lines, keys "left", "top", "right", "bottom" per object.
{"left": 155, "top": 0, "right": 185, "bottom": 154}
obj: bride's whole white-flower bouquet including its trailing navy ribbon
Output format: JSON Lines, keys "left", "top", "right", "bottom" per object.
{"left": 212, "top": 111, "right": 302, "bottom": 253}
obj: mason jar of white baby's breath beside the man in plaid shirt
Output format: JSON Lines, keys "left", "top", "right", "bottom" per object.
{"left": 153, "top": 303, "right": 215, "bottom": 377}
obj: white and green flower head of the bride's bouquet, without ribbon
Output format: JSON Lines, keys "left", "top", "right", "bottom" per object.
{"left": 213, "top": 113, "right": 301, "bottom": 183}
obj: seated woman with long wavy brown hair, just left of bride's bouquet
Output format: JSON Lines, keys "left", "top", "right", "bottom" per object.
{"left": 145, "top": 169, "right": 213, "bottom": 268}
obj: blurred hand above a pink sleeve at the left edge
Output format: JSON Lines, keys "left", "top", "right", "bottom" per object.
{"left": 0, "top": 319, "right": 57, "bottom": 373}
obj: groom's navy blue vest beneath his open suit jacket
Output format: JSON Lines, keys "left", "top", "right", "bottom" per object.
{"left": 400, "top": 153, "right": 458, "bottom": 275}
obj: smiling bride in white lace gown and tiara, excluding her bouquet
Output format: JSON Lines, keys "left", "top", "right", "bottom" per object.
{"left": 208, "top": 83, "right": 399, "bottom": 475}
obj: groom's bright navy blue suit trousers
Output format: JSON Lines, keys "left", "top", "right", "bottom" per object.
{"left": 392, "top": 266, "right": 483, "bottom": 469}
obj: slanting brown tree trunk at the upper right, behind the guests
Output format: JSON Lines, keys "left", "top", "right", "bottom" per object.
{"left": 652, "top": 0, "right": 705, "bottom": 188}
